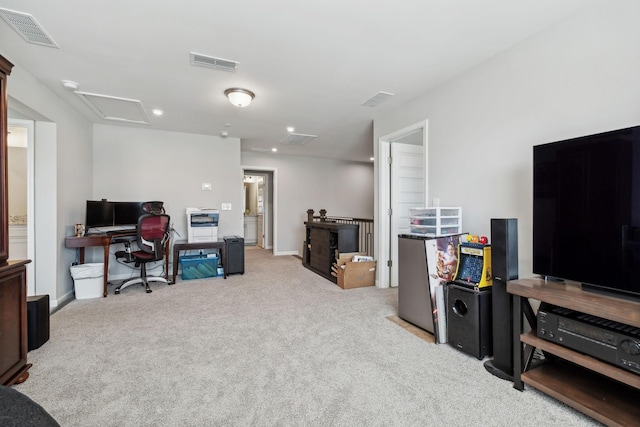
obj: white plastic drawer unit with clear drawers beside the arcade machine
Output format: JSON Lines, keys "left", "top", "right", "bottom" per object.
{"left": 409, "top": 207, "right": 462, "bottom": 236}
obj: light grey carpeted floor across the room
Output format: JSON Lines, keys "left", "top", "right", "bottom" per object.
{"left": 16, "top": 249, "right": 598, "bottom": 427}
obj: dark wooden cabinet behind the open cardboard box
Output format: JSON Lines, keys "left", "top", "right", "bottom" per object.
{"left": 302, "top": 221, "right": 359, "bottom": 283}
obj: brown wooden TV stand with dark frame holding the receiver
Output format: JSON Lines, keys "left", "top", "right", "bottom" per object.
{"left": 507, "top": 279, "right": 640, "bottom": 426}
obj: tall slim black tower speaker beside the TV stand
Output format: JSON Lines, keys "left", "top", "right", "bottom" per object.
{"left": 484, "top": 218, "right": 518, "bottom": 380}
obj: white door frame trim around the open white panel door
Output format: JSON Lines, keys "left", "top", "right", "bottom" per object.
{"left": 374, "top": 119, "right": 429, "bottom": 288}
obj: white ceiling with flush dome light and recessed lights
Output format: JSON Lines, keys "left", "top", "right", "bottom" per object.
{"left": 0, "top": 0, "right": 589, "bottom": 161}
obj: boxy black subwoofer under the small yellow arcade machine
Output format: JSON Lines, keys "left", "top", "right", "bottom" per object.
{"left": 447, "top": 284, "right": 492, "bottom": 359}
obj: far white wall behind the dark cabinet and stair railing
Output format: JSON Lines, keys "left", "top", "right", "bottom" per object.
{"left": 242, "top": 152, "right": 373, "bottom": 254}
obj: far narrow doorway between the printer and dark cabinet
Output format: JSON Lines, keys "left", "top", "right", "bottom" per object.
{"left": 242, "top": 167, "right": 277, "bottom": 254}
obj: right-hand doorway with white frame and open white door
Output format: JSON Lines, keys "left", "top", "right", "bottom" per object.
{"left": 375, "top": 120, "right": 428, "bottom": 288}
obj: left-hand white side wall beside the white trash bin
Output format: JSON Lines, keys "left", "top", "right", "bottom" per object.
{"left": 0, "top": 56, "right": 92, "bottom": 307}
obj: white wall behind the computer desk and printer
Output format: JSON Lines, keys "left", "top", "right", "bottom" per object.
{"left": 93, "top": 125, "right": 243, "bottom": 275}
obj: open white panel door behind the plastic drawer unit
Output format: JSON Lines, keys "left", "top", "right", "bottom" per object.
{"left": 389, "top": 142, "right": 425, "bottom": 287}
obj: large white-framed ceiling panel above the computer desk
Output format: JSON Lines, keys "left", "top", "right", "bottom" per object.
{"left": 75, "top": 91, "right": 149, "bottom": 124}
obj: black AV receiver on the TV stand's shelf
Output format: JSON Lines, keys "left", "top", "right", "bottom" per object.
{"left": 537, "top": 303, "right": 640, "bottom": 374}
